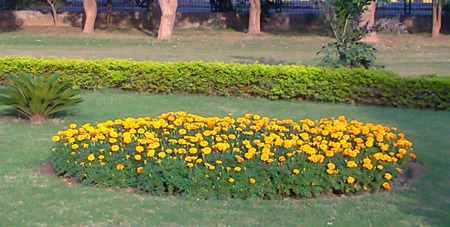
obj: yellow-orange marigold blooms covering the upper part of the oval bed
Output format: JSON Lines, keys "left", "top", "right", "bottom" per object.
{"left": 52, "top": 111, "right": 415, "bottom": 189}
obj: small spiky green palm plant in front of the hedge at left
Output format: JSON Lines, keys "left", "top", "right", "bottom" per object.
{"left": 0, "top": 74, "right": 83, "bottom": 124}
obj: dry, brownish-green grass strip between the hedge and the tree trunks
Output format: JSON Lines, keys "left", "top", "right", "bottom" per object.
{"left": 0, "top": 27, "right": 450, "bottom": 76}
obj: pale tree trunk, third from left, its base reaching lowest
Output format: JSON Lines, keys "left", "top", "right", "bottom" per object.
{"left": 158, "top": 0, "right": 178, "bottom": 40}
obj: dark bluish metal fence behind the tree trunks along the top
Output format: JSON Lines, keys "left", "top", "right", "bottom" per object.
{"left": 0, "top": 0, "right": 432, "bottom": 16}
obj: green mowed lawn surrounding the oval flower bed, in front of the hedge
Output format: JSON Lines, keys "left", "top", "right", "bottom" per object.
{"left": 0, "top": 91, "right": 450, "bottom": 226}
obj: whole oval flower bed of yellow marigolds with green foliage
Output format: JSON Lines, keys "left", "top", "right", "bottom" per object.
{"left": 51, "top": 112, "right": 415, "bottom": 198}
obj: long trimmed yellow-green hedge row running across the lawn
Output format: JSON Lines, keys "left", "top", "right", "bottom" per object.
{"left": 0, "top": 57, "right": 450, "bottom": 110}
